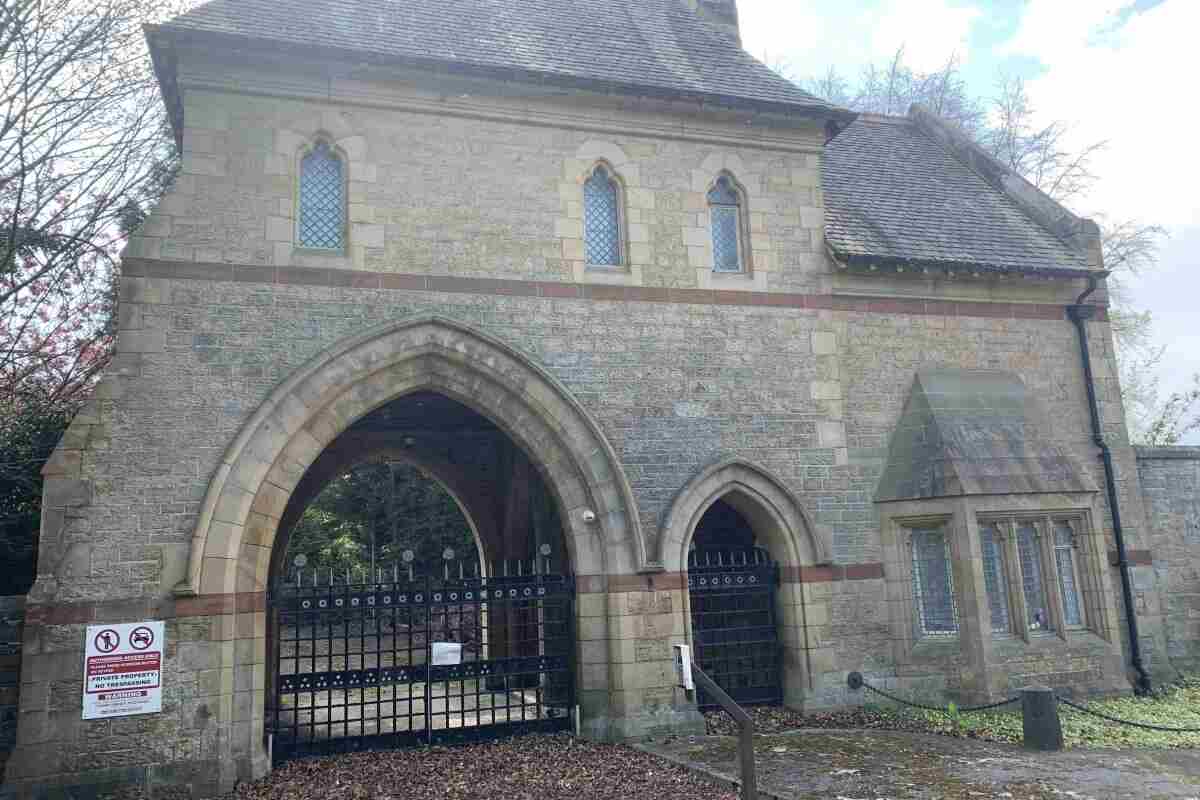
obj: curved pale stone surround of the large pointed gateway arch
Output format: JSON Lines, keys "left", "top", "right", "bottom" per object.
{"left": 180, "top": 318, "right": 648, "bottom": 594}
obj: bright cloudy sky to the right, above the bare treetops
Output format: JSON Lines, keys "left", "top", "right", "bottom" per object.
{"left": 738, "top": 0, "right": 1200, "bottom": 443}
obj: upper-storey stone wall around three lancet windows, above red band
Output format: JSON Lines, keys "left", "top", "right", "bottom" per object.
{"left": 127, "top": 54, "right": 823, "bottom": 296}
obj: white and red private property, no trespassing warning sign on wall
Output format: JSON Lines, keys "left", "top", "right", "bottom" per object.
{"left": 83, "top": 622, "right": 166, "bottom": 720}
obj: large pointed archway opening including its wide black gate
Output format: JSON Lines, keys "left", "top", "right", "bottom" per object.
{"left": 266, "top": 391, "right": 575, "bottom": 760}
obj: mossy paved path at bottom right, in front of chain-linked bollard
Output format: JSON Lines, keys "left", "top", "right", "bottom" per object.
{"left": 642, "top": 730, "right": 1200, "bottom": 800}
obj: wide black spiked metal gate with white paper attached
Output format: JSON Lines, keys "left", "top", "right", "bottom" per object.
{"left": 268, "top": 559, "right": 575, "bottom": 760}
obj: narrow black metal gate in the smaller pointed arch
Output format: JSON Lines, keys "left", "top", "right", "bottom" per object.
{"left": 688, "top": 547, "right": 784, "bottom": 709}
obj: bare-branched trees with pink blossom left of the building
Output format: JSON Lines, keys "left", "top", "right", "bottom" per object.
{"left": 0, "top": 0, "right": 188, "bottom": 591}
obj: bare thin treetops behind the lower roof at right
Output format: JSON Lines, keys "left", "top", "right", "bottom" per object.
{"left": 784, "top": 48, "right": 1200, "bottom": 445}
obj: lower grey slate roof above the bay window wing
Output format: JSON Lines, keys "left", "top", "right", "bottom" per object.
{"left": 823, "top": 115, "right": 1087, "bottom": 271}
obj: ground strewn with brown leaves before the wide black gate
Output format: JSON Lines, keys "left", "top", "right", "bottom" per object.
{"left": 227, "top": 734, "right": 737, "bottom": 800}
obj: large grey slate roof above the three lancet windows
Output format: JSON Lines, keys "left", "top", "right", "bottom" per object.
{"left": 157, "top": 0, "right": 832, "bottom": 115}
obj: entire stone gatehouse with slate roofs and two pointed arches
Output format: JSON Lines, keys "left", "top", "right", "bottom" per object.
{"left": 6, "top": 0, "right": 1200, "bottom": 795}
